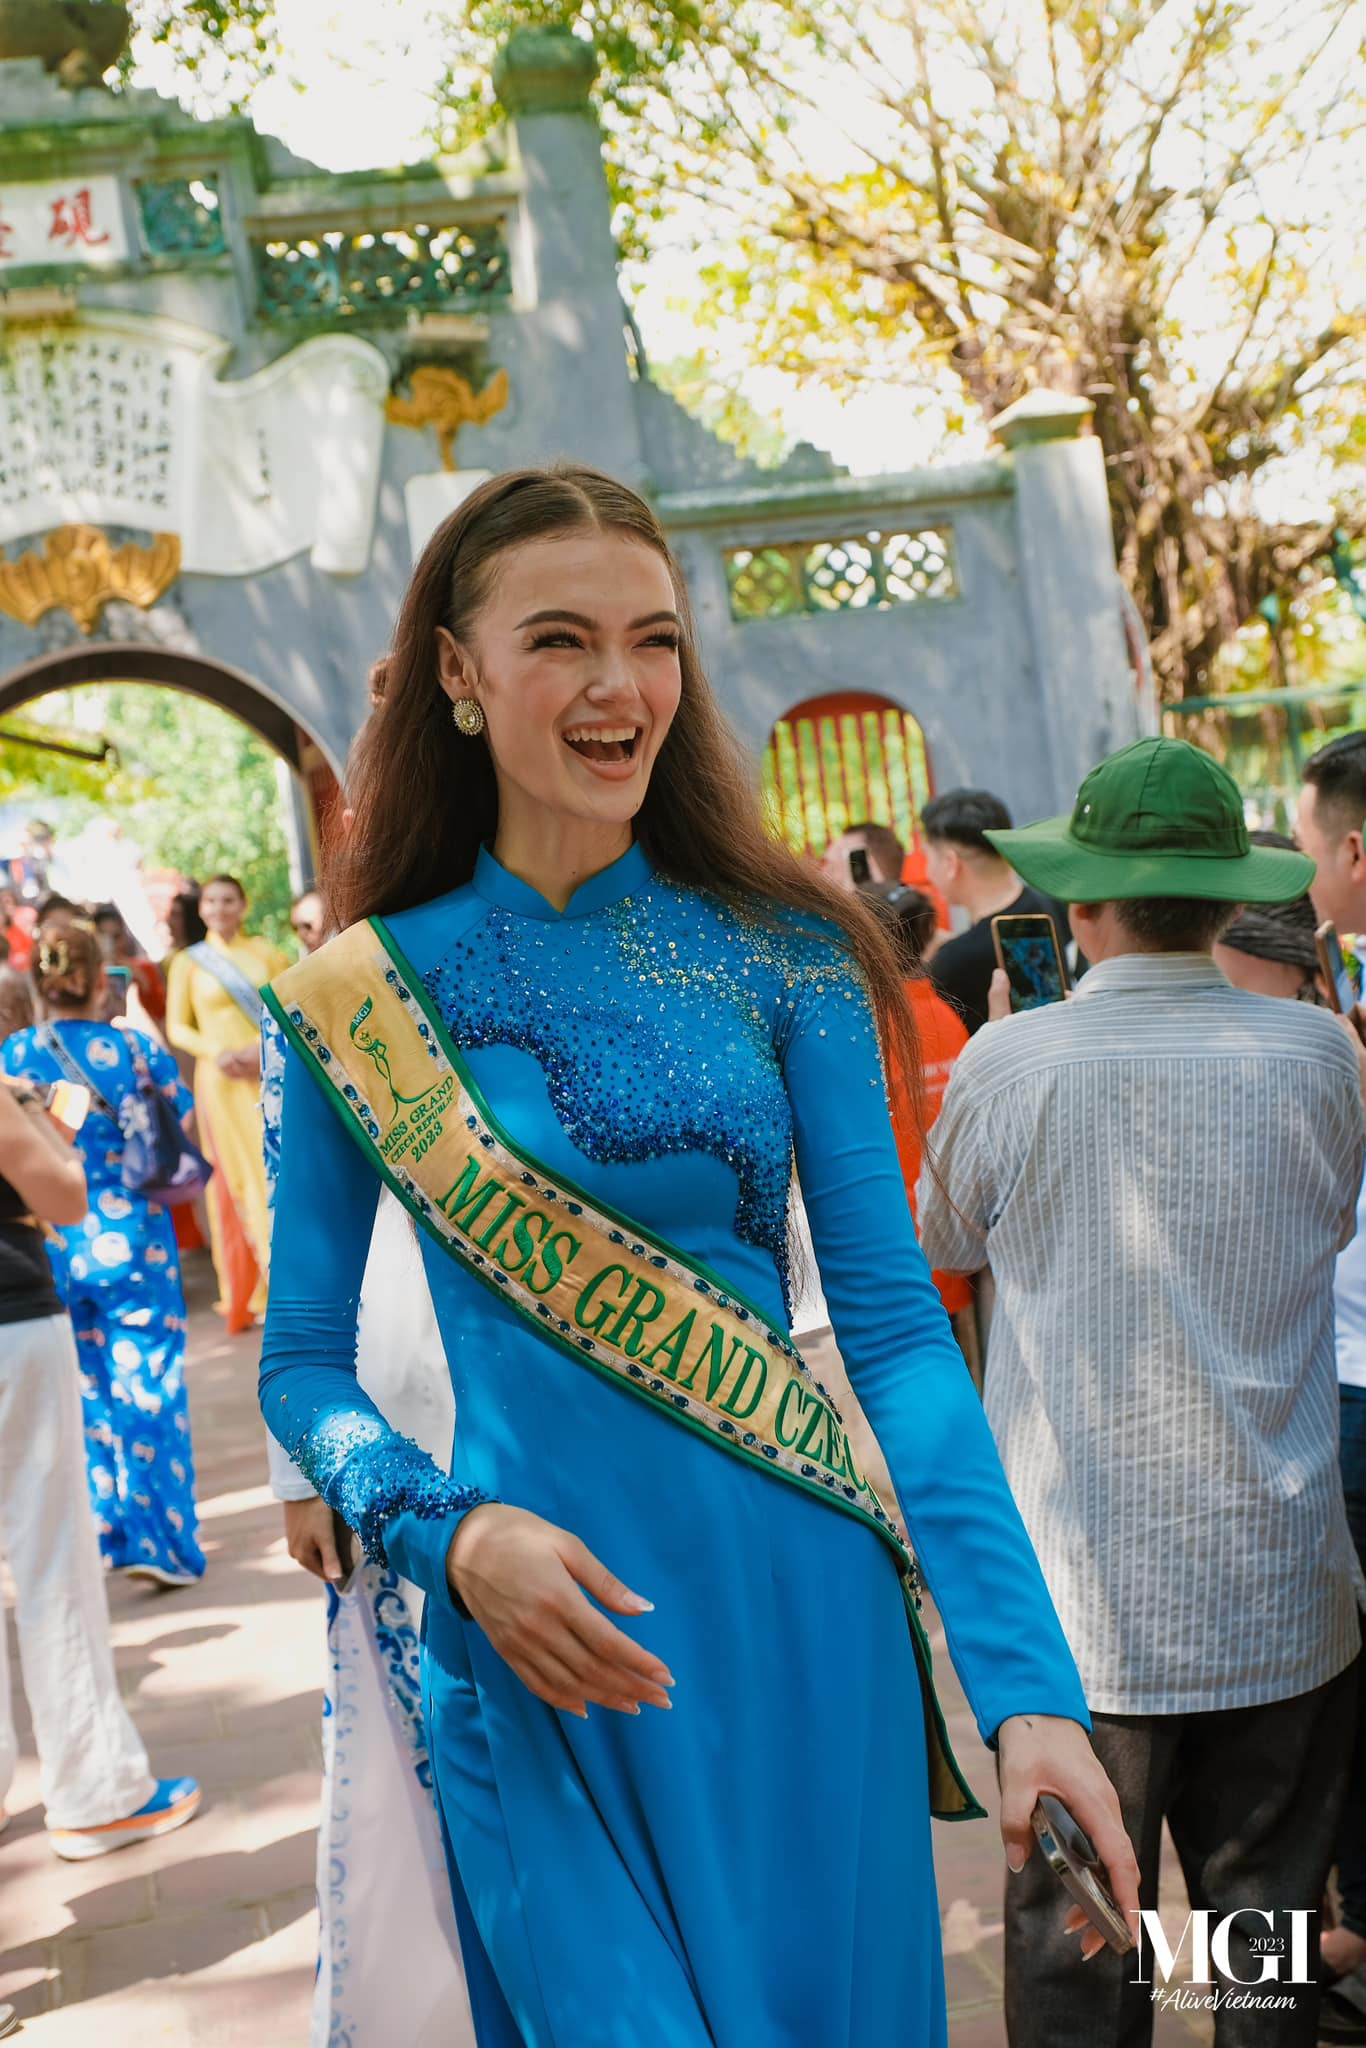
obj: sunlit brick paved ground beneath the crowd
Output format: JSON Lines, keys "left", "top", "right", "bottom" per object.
{"left": 0, "top": 1266, "right": 1208, "bottom": 2048}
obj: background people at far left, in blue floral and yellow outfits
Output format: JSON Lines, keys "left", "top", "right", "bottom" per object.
{"left": 0, "top": 860, "right": 315, "bottom": 1933}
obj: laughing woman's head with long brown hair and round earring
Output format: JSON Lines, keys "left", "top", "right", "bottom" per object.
{"left": 328, "top": 465, "right": 920, "bottom": 1075}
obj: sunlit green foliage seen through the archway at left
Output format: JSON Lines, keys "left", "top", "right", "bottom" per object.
{"left": 0, "top": 684, "right": 291, "bottom": 944}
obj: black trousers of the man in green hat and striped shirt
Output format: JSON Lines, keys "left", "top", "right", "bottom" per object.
{"left": 1006, "top": 1665, "right": 1356, "bottom": 2048}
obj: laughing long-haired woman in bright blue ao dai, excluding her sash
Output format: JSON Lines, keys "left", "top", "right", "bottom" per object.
{"left": 262, "top": 467, "right": 1137, "bottom": 2048}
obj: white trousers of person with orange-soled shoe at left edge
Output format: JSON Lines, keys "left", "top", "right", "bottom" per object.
{"left": 0, "top": 1315, "right": 156, "bottom": 1827}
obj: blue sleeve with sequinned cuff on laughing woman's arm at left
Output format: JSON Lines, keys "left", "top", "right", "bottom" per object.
{"left": 260, "top": 1053, "right": 487, "bottom": 1608}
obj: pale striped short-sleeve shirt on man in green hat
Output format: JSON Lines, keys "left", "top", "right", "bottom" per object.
{"left": 920, "top": 954, "right": 1364, "bottom": 1714}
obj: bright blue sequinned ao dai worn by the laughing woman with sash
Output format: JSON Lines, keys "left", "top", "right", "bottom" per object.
{"left": 262, "top": 848, "right": 1085, "bottom": 2048}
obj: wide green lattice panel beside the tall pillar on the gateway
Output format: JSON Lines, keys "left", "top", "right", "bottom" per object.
{"left": 252, "top": 221, "right": 512, "bottom": 319}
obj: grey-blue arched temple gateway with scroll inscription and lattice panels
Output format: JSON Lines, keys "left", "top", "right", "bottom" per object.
{"left": 0, "top": 0, "right": 1139, "bottom": 864}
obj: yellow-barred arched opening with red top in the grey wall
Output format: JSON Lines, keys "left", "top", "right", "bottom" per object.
{"left": 760, "top": 705, "right": 930, "bottom": 854}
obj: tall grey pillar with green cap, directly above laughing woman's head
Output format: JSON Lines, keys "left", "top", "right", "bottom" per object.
{"left": 494, "top": 29, "right": 649, "bottom": 487}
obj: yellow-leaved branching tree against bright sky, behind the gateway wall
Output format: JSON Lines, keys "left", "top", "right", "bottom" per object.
{"left": 135, "top": 0, "right": 1366, "bottom": 698}
